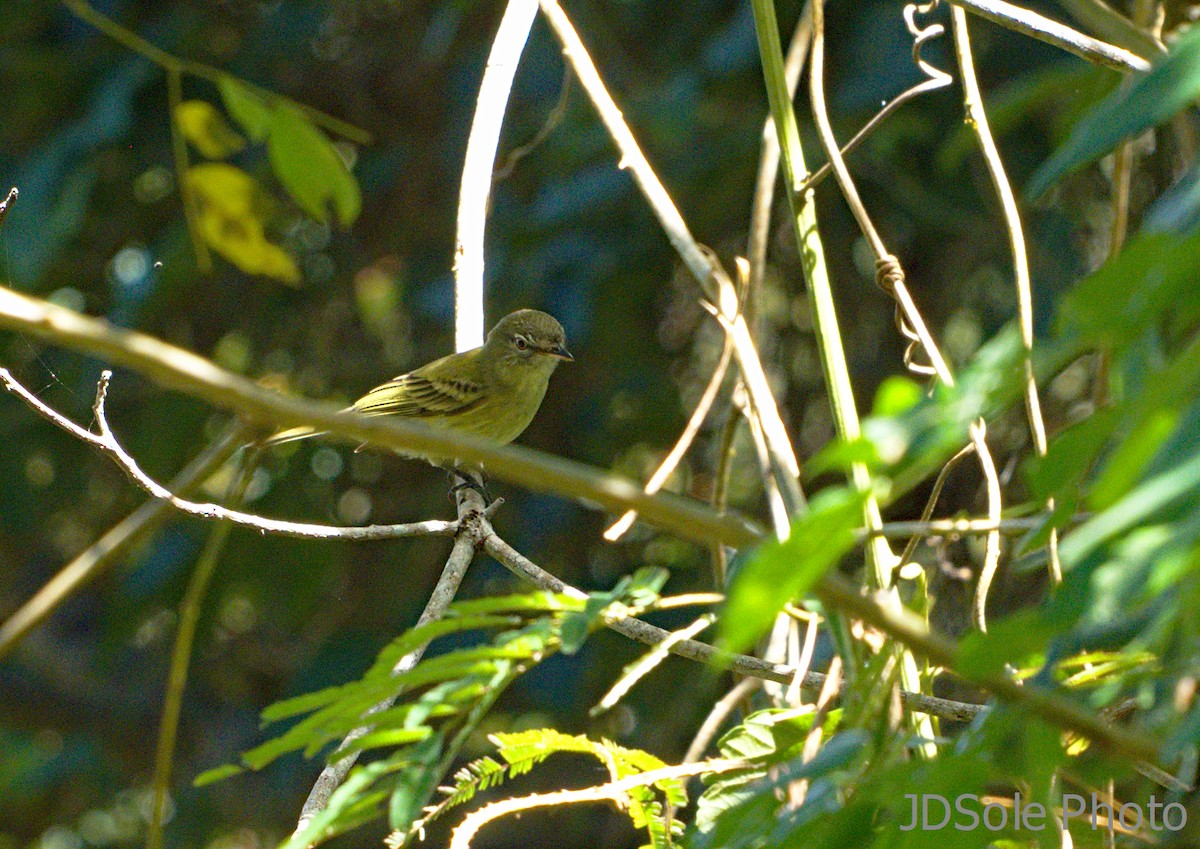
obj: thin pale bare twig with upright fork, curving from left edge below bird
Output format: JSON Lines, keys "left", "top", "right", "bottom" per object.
{"left": 0, "top": 368, "right": 456, "bottom": 541}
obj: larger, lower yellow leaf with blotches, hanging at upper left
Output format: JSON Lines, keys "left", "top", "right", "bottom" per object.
{"left": 187, "top": 162, "right": 300, "bottom": 285}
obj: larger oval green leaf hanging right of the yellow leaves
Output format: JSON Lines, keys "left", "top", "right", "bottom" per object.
{"left": 266, "top": 107, "right": 362, "bottom": 227}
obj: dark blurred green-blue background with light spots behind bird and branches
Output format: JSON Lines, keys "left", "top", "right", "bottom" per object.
{"left": 0, "top": 0, "right": 1152, "bottom": 849}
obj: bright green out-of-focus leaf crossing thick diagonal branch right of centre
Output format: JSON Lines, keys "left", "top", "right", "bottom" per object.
{"left": 721, "top": 487, "right": 866, "bottom": 651}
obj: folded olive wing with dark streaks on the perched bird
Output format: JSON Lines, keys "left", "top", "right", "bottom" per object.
{"left": 353, "top": 351, "right": 486, "bottom": 419}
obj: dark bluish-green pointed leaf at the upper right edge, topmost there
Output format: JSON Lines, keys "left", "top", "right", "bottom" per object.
{"left": 1027, "top": 24, "right": 1200, "bottom": 197}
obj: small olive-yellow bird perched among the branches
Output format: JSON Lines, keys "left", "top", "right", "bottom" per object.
{"left": 264, "top": 309, "right": 575, "bottom": 470}
